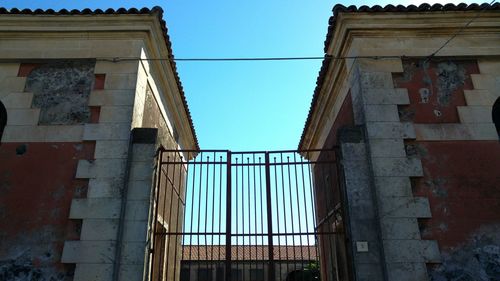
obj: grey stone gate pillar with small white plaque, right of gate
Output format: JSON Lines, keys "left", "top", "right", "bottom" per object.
{"left": 339, "top": 127, "right": 384, "bottom": 281}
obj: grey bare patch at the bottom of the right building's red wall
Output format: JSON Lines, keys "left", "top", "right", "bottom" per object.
{"left": 429, "top": 225, "right": 500, "bottom": 281}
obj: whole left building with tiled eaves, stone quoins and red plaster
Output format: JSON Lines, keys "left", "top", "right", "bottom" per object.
{"left": 0, "top": 8, "right": 199, "bottom": 281}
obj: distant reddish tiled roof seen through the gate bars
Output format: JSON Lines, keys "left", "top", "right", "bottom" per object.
{"left": 182, "top": 245, "right": 318, "bottom": 261}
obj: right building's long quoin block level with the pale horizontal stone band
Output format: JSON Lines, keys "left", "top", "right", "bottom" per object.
{"left": 366, "top": 122, "right": 415, "bottom": 139}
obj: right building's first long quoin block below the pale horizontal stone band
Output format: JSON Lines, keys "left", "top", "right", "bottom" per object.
{"left": 372, "top": 157, "right": 423, "bottom": 177}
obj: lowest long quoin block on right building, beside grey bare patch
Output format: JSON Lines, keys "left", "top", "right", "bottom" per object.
{"left": 384, "top": 240, "right": 441, "bottom": 263}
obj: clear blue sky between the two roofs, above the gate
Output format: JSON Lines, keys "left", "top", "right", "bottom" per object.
{"left": 0, "top": 0, "right": 472, "bottom": 150}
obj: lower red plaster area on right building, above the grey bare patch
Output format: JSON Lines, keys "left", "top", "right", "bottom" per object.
{"left": 414, "top": 141, "right": 500, "bottom": 248}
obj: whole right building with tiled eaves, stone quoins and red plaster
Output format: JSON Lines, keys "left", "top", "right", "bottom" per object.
{"left": 299, "top": 3, "right": 500, "bottom": 281}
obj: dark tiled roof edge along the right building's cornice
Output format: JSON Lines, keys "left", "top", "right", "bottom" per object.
{"left": 298, "top": 2, "right": 500, "bottom": 149}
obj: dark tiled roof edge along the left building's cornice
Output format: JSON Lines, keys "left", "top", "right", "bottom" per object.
{"left": 0, "top": 6, "right": 199, "bottom": 149}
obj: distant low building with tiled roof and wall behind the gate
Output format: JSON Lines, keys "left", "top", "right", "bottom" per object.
{"left": 180, "top": 245, "right": 318, "bottom": 281}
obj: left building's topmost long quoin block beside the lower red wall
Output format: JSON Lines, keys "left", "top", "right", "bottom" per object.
{"left": 75, "top": 159, "right": 126, "bottom": 179}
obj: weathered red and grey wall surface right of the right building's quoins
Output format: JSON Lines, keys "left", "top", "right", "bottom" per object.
{"left": 394, "top": 58, "right": 500, "bottom": 280}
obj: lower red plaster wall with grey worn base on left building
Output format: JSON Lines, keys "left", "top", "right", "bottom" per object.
{"left": 0, "top": 142, "right": 94, "bottom": 280}
